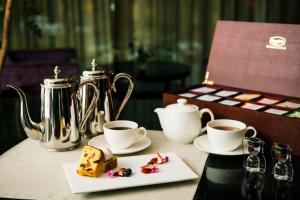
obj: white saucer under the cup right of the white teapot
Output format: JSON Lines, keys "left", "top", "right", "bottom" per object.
{"left": 194, "top": 134, "right": 248, "bottom": 156}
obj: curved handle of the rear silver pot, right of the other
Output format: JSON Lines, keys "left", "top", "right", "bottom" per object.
{"left": 111, "top": 73, "right": 134, "bottom": 119}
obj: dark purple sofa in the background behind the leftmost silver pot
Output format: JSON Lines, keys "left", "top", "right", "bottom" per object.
{"left": 0, "top": 48, "right": 79, "bottom": 90}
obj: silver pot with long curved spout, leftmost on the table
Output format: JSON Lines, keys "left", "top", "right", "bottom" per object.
{"left": 7, "top": 66, "right": 99, "bottom": 151}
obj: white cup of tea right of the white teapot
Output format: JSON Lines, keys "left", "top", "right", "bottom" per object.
{"left": 207, "top": 119, "right": 257, "bottom": 151}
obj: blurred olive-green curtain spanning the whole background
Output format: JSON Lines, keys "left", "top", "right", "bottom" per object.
{"left": 5, "top": 0, "right": 300, "bottom": 83}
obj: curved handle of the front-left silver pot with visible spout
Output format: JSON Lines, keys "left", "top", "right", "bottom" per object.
{"left": 76, "top": 81, "right": 100, "bottom": 132}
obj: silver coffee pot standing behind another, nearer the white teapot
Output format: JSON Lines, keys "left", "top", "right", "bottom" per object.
{"left": 80, "top": 59, "right": 134, "bottom": 138}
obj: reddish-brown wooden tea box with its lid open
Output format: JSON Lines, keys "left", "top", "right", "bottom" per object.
{"left": 163, "top": 21, "right": 300, "bottom": 155}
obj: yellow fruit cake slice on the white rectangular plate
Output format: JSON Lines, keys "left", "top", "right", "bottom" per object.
{"left": 76, "top": 146, "right": 117, "bottom": 177}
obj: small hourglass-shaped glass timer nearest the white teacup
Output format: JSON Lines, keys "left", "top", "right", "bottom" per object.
{"left": 244, "top": 138, "right": 266, "bottom": 173}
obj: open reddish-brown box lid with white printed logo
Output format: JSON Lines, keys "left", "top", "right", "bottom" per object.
{"left": 207, "top": 21, "right": 300, "bottom": 98}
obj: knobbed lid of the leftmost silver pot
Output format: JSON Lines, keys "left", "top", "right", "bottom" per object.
{"left": 44, "top": 66, "right": 73, "bottom": 88}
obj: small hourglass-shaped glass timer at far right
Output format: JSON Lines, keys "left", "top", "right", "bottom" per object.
{"left": 271, "top": 142, "right": 294, "bottom": 182}
